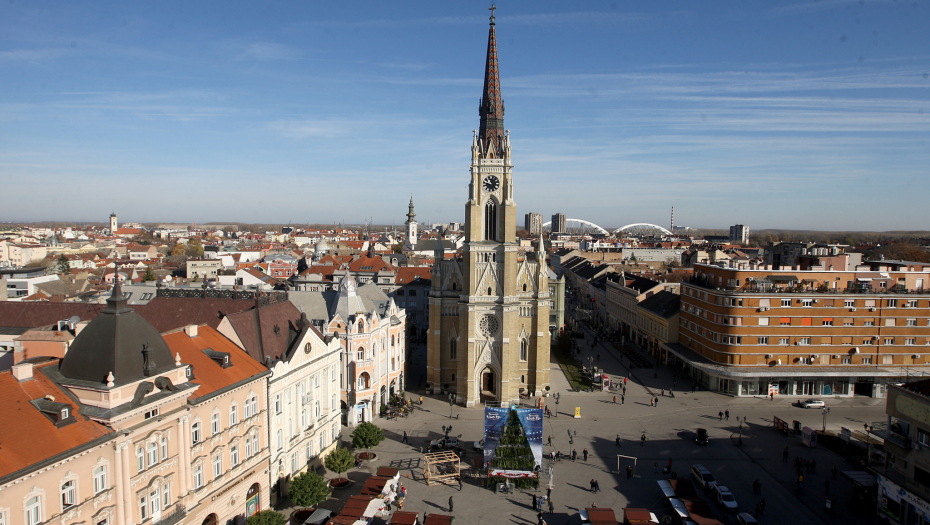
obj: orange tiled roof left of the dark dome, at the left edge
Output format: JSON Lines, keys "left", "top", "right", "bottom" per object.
{"left": 0, "top": 359, "right": 111, "bottom": 477}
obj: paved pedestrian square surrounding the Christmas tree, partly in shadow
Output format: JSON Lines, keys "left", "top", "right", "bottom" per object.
{"left": 288, "top": 328, "right": 884, "bottom": 525}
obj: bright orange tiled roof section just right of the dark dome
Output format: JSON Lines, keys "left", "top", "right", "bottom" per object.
{"left": 164, "top": 326, "right": 267, "bottom": 401}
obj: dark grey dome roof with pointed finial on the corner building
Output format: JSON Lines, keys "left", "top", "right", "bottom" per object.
{"left": 59, "top": 279, "right": 175, "bottom": 385}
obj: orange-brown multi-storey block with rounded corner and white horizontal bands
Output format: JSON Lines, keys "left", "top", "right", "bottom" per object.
{"left": 672, "top": 261, "right": 930, "bottom": 397}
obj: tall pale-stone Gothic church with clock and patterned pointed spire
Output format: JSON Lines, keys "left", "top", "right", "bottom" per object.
{"left": 427, "top": 11, "right": 550, "bottom": 406}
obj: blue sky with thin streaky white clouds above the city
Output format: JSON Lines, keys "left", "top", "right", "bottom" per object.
{"left": 0, "top": 0, "right": 930, "bottom": 230}
